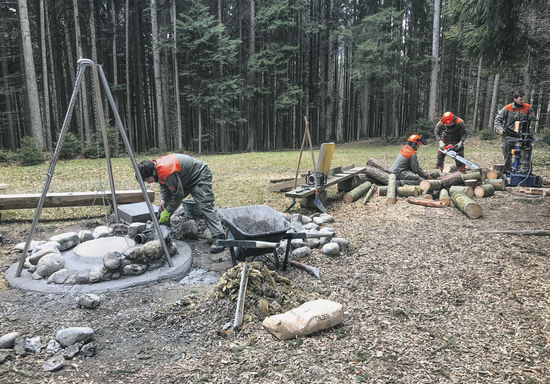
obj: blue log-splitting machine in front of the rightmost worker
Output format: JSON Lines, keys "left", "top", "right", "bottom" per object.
{"left": 506, "top": 121, "right": 542, "bottom": 187}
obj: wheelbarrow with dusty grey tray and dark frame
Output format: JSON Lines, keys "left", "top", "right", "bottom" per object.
{"left": 218, "top": 205, "right": 332, "bottom": 270}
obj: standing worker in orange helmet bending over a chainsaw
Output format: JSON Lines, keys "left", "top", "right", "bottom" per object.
{"left": 435, "top": 112, "right": 468, "bottom": 172}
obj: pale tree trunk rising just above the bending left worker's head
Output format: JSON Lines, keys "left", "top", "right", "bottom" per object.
{"left": 151, "top": 0, "right": 166, "bottom": 153}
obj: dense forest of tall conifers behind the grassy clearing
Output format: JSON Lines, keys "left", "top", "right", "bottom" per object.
{"left": 0, "top": 0, "right": 550, "bottom": 153}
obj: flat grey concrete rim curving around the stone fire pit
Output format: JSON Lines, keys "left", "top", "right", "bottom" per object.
{"left": 5, "top": 240, "right": 193, "bottom": 293}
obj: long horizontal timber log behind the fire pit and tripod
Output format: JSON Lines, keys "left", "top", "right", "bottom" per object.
{"left": 0, "top": 189, "right": 155, "bottom": 209}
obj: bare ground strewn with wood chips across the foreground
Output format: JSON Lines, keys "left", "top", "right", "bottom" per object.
{"left": 0, "top": 186, "right": 550, "bottom": 384}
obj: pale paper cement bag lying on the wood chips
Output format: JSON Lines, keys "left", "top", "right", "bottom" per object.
{"left": 262, "top": 299, "right": 344, "bottom": 340}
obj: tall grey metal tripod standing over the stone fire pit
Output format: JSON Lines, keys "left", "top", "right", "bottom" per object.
{"left": 16, "top": 59, "right": 174, "bottom": 277}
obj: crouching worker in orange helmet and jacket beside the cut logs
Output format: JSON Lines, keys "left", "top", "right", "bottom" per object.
{"left": 390, "top": 134, "right": 430, "bottom": 186}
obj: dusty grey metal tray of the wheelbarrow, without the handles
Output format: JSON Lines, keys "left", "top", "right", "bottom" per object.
{"left": 218, "top": 205, "right": 290, "bottom": 260}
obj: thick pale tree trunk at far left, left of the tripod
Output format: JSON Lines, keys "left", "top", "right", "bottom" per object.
{"left": 17, "top": 0, "right": 45, "bottom": 149}
